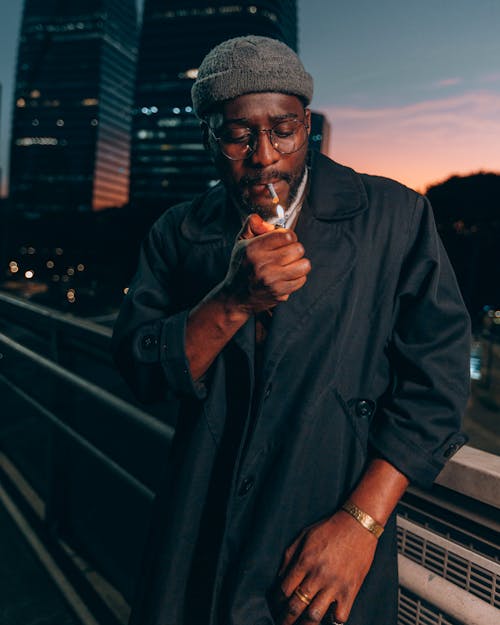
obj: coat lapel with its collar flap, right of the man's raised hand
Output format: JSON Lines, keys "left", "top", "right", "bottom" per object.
{"left": 263, "top": 154, "right": 367, "bottom": 380}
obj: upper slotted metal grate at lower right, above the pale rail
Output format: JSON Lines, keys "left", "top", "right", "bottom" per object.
{"left": 398, "top": 519, "right": 500, "bottom": 608}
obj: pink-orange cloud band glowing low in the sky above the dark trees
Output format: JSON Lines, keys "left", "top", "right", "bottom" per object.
{"left": 323, "top": 91, "right": 500, "bottom": 191}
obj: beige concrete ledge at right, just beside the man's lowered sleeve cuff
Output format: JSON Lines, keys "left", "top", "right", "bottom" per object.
{"left": 436, "top": 445, "right": 500, "bottom": 509}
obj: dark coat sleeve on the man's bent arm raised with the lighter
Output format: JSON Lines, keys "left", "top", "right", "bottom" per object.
{"left": 112, "top": 211, "right": 205, "bottom": 402}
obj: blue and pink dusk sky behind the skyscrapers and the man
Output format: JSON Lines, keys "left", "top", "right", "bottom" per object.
{"left": 0, "top": 0, "right": 500, "bottom": 191}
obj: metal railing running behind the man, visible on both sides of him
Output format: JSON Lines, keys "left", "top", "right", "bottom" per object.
{"left": 0, "top": 294, "right": 500, "bottom": 625}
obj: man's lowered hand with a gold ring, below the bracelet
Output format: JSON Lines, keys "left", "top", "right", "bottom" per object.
{"left": 277, "top": 511, "right": 377, "bottom": 625}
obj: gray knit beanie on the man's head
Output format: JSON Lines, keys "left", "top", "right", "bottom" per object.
{"left": 191, "top": 35, "right": 313, "bottom": 117}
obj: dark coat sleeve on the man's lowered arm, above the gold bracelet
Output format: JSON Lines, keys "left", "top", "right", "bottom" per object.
{"left": 371, "top": 196, "right": 470, "bottom": 486}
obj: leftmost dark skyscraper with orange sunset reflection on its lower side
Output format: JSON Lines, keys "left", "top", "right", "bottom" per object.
{"left": 10, "top": 0, "right": 137, "bottom": 215}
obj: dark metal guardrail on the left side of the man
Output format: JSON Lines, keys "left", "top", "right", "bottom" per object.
{"left": 0, "top": 296, "right": 173, "bottom": 599}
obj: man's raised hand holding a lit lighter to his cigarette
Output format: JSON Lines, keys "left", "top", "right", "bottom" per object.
{"left": 223, "top": 214, "right": 311, "bottom": 314}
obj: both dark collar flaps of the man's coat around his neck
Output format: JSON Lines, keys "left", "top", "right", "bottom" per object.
{"left": 181, "top": 152, "right": 368, "bottom": 243}
